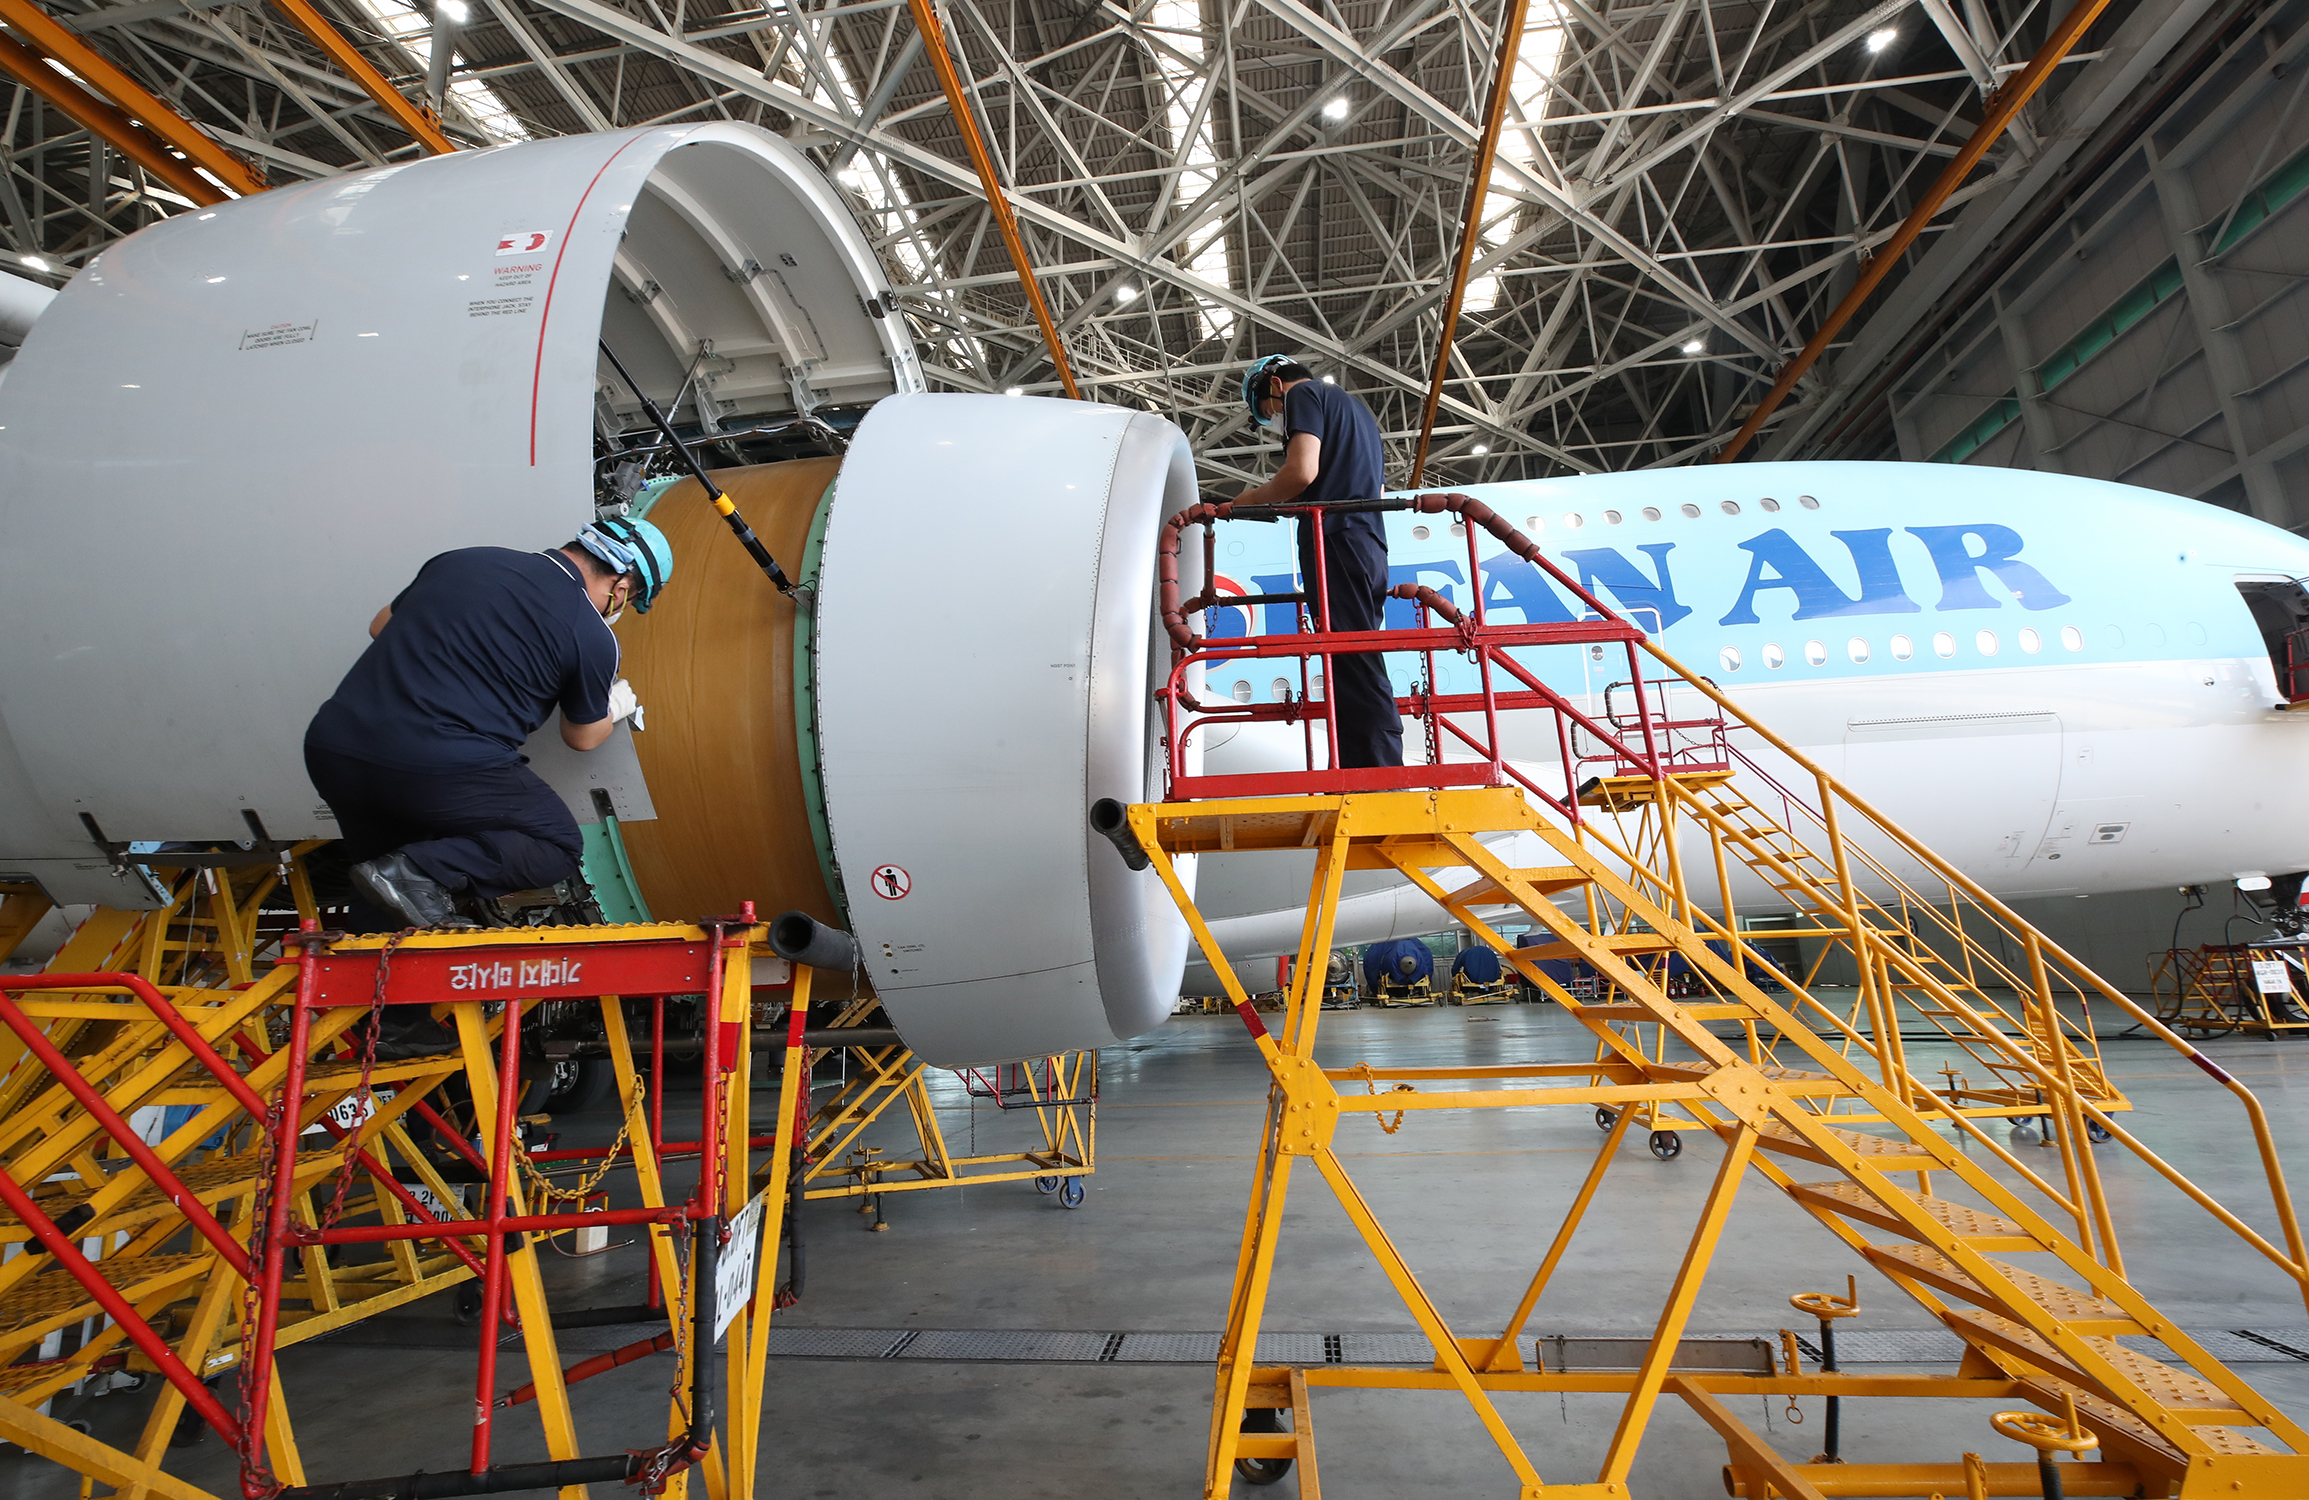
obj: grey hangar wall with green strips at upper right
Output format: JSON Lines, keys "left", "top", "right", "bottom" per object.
{"left": 1891, "top": 2, "right": 2309, "bottom": 526}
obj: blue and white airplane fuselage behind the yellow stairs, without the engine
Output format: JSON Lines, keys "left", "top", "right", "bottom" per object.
{"left": 1189, "top": 464, "right": 2309, "bottom": 964}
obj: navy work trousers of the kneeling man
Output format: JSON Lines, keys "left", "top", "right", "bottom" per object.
{"left": 305, "top": 743, "right": 584, "bottom": 895}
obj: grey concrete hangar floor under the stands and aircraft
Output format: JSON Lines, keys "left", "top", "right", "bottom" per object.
{"left": 13, "top": 1006, "right": 2309, "bottom": 1500}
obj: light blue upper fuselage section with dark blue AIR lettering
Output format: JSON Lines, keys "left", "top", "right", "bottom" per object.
{"left": 1205, "top": 464, "right": 2309, "bottom": 702}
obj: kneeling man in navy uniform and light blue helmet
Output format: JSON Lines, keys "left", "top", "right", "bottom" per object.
{"left": 305, "top": 522, "right": 674, "bottom": 928}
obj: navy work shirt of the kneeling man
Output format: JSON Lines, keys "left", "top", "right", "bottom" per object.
{"left": 305, "top": 547, "right": 617, "bottom": 771}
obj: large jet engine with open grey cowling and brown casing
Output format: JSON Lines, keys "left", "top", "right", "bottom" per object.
{"left": 0, "top": 125, "right": 1194, "bottom": 1064}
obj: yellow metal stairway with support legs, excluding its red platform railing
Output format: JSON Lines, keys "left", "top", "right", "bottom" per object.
{"left": 1131, "top": 778, "right": 2309, "bottom": 1498}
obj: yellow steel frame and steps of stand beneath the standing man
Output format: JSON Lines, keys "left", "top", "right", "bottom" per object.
{"left": 1129, "top": 766, "right": 2309, "bottom": 1500}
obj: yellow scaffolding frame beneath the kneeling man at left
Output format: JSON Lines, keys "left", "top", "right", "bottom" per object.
{"left": 0, "top": 858, "right": 810, "bottom": 1500}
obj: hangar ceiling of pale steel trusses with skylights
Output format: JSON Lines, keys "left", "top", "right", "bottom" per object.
{"left": 0, "top": 0, "right": 2309, "bottom": 522}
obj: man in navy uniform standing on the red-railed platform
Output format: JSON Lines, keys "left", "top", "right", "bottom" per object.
{"left": 1235, "top": 355, "right": 1404, "bottom": 766}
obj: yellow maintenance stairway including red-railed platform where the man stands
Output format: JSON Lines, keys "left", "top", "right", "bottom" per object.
{"left": 1131, "top": 484, "right": 2309, "bottom": 1500}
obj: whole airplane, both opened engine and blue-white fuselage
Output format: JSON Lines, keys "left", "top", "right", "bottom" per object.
{"left": 0, "top": 122, "right": 2309, "bottom": 1066}
